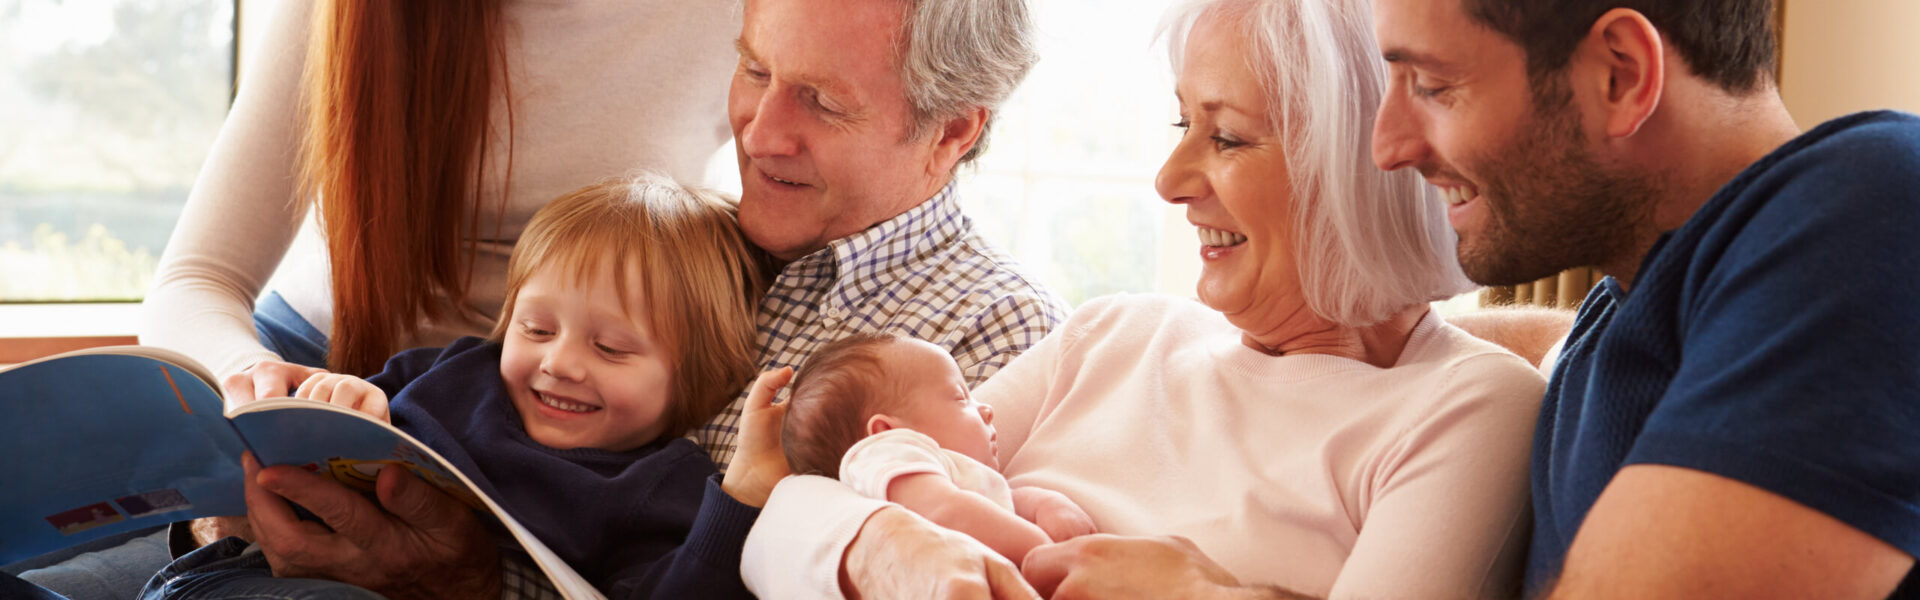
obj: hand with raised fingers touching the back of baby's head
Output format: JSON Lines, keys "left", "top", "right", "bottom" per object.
{"left": 720, "top": 367, "right": 793, "bottom": 508}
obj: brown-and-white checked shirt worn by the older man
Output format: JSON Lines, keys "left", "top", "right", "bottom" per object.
{"left": 687, "top": 185, "right": 1066, "bottom": 471}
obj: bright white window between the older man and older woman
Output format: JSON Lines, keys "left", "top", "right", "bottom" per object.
{"left": 960, "top": 0, "right": 1200, "bottom": 306}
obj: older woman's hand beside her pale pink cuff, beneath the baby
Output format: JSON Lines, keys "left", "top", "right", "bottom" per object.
{"left": 841, "top": 506, "right": 1041, "bottom": 600}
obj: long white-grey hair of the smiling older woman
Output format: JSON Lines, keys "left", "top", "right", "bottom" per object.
{"left": 1162, "top": 0, "right": 1473, "bottom": 327}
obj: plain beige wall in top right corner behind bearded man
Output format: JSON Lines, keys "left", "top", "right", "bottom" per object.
{"left": 1780, "top": 0, "right": 1920, "bottom": 129}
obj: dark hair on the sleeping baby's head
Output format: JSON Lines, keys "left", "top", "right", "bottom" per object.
{"left": 780, "top": 333, "right": 900, "bottom": 479}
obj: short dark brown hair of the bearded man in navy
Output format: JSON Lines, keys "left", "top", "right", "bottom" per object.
{"left": 1461, "top": 0, "right": 1774, "bottom": 96}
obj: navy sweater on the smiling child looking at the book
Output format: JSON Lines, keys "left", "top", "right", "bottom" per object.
{"left": 367, "top": 337, "right": 760, "bottom": 598}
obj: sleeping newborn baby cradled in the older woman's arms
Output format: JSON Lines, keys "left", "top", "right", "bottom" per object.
{"left": 780, "top": 335, "right": 1094, "bottom": 563}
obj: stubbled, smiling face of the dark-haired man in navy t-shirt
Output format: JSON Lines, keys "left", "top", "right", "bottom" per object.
{"left": 1373, "top": 0, "right": 1651, "bottom": 285}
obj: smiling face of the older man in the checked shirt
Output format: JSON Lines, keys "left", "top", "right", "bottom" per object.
{"left": 728, "top": 0, "right": 947, "bottom": 262}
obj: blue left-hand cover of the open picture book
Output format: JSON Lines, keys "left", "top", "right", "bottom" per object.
{"left": 0, "top": 346, "right": 246, "bottom": 563}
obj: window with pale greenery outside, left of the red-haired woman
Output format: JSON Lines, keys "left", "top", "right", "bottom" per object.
{"left": 0, "top": 0, "right": 234, "bottom": 302}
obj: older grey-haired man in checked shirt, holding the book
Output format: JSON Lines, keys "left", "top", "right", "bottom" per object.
{"left": 222, "top": 0, "right": 1064, "bottom": 596}
